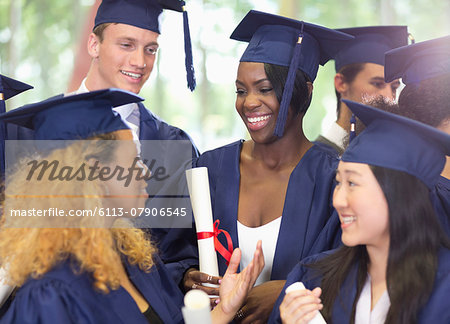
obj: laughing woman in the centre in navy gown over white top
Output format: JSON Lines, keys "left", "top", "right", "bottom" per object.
{"left": 185, "top": 10, "right": 351, "bottom": 323}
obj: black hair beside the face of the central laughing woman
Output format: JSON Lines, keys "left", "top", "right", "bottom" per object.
{"left": 264, "top": 63, "right": 312, "bottom": 115}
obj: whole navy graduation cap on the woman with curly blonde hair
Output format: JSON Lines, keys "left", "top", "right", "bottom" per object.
{"left": 0, "top": 89, "right": 143, "bottom": 140}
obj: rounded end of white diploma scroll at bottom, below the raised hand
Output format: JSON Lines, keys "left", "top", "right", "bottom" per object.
{"left": 181, "top": 289, "right": 212, "bottom": 324}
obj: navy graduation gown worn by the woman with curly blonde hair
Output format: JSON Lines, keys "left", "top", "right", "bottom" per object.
{"left": 0, "top": 254, "right": 183, "bottom": 324}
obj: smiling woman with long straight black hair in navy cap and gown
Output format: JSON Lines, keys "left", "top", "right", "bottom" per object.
{"left": 270, "top": 100, "right": 450, "bottom": 324}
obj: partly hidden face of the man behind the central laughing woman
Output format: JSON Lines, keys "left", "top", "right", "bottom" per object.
{"left": 341, "top": 63, "right": 400, "bottom": 102}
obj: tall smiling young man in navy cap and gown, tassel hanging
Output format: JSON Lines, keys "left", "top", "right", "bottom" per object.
{"left": 77, "top": 0, "right": 199, "bottom": 288}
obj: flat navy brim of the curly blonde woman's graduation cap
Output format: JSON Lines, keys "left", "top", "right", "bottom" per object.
{"left": 0, "top": 88, "right": 144, "bottom": 129}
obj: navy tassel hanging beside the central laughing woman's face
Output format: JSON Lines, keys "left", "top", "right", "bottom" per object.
{"left": 274, "top": 21, "right": 304, "bottom": 137}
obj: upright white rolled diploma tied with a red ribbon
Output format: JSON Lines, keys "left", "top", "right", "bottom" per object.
{"left": 186, "top": 167, "right": 219, "bottom": 278}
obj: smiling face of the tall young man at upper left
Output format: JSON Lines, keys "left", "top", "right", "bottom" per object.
{"left": 86, "top": 24, "right": 159, "bottom": 94}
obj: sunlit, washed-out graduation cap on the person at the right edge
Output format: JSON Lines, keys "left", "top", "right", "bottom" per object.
{"left": 384, "top": 36, "right": 450, "bottom": 84}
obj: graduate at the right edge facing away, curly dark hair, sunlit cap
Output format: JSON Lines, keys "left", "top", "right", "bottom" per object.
{"left": 385, "top": 36, "right": 450, "bottom": 237}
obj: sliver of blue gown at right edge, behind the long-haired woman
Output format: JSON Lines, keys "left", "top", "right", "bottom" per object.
{"left": 430, "top": 176, "right": 450, "bottom": 237}
